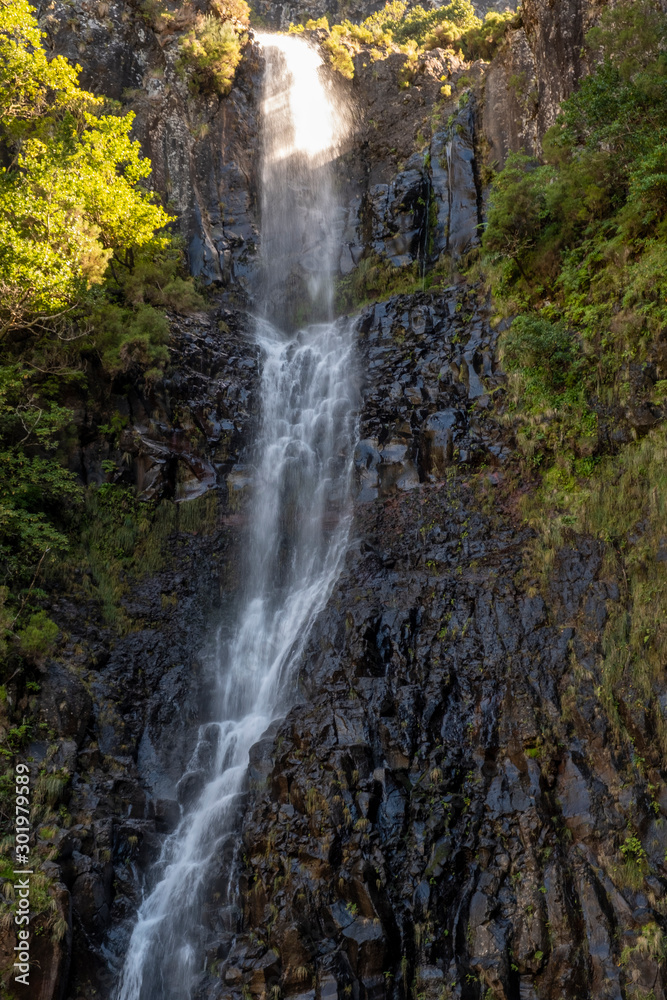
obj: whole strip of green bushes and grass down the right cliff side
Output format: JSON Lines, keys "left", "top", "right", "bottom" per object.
{"left": 483, "top": 0, "right": 667, "bottom": 764}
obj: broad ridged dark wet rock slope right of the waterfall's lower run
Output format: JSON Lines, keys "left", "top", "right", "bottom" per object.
{"left": 209, "top": 474, "right": 663, "bottom": 998}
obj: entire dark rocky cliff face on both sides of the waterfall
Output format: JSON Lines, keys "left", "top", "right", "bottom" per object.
{"left": 2, "top": 0, "right": 667, "bottom": 1000}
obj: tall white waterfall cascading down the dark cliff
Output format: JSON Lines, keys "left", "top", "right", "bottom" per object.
{"left": 116, "top": 27, "right": 355, "bottom": 1000}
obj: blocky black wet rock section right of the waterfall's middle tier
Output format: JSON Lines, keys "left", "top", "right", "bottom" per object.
{"left": 356, "top": 288, "right": 508, "bottom": 490}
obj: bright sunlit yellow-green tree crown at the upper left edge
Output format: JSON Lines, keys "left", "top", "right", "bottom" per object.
{"left": 0, "top": 0, "right": 175, "bottom": 338}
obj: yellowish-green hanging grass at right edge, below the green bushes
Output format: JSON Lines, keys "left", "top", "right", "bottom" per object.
{"left": 523, "top": 424, "right": 667, "bottom": 766}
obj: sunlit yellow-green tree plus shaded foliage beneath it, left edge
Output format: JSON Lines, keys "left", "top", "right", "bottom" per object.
{"left": 0, "top": 0, "right": 201, "bottom": 658}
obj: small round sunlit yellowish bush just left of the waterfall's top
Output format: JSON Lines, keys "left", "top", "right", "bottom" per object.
{"left": 177, "top": 15, "right": 245, "bottom": 97}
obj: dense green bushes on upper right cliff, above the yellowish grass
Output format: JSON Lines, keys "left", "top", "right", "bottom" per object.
{"left": 483, "top": 0, "right": 667, "bottom": 461}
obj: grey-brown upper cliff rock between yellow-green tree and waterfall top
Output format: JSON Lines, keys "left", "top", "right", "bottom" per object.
{"left": 43, "top": 0, "right": 260, "bottom": 297}
